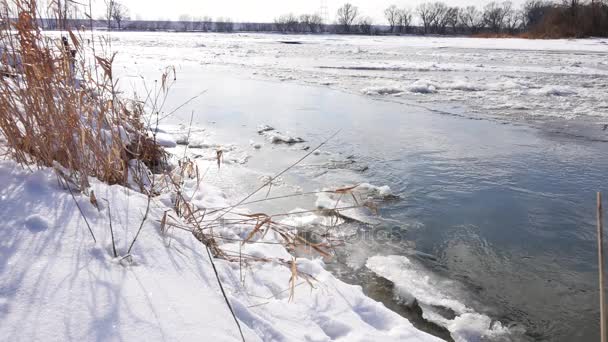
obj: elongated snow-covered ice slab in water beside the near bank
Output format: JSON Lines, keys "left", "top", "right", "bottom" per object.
{"left": 366, "top": 255, "right": 511, "bottom": 342}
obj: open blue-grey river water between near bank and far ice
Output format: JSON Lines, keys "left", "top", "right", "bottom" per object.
{"left": 123, "top": 63, "right": 608, "bottom": 341}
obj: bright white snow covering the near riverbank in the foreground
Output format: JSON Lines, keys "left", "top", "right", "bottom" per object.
{"left": 0, "top": 161, "right": 439, "bottom": 341}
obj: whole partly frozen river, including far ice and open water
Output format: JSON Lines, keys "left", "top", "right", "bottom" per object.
{"left": 113, "top": 34, "right": 608, "bottom": 341}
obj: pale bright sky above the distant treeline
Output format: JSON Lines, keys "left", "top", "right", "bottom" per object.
{"left": 94, "top": 0, "right": 523, "bottom": 24}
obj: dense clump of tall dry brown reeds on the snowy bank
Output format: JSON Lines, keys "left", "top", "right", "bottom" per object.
{"left": 0, "top": 0, "right": 166, "bottom": 188}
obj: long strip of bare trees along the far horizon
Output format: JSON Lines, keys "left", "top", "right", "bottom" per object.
{"left": 3, "top": 0, "right": 608, "bottom": 38}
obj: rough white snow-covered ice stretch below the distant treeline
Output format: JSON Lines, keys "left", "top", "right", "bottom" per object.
{"left": 113, "top": 33, "right": 608, "bottom": 123}
